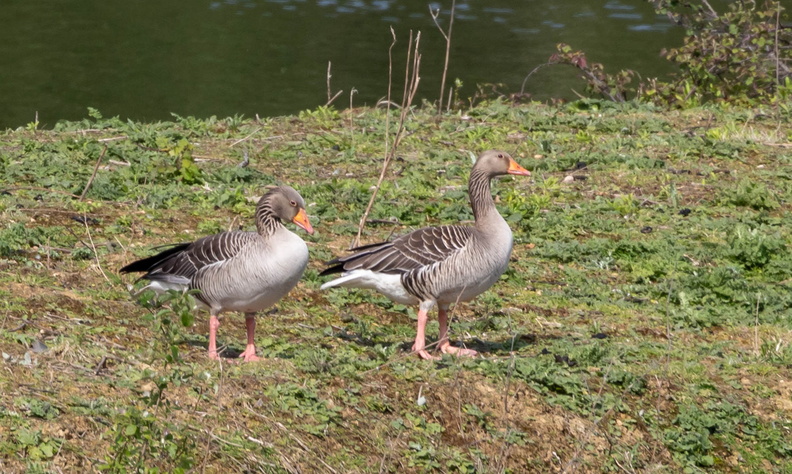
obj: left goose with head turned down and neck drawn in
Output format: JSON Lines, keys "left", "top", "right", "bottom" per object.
{"left": 120, "top": 186, "right": 313, "bottom": 361}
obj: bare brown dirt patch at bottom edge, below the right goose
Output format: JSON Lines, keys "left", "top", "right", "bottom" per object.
{"left": 358, "top": 372, "right": 670, "bottom": 472}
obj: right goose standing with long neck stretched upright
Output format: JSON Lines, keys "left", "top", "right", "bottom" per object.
{"left": 320, "top": 151, "right": 531, "bottom": 359}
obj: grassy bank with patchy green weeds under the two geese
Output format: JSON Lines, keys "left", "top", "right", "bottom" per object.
{"left": 0, "top": 102, "right": 792, "bottom": 473}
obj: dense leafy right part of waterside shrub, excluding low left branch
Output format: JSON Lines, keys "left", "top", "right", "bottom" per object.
{"left": 646, "top": 0, "right": 792, "bottom": 103}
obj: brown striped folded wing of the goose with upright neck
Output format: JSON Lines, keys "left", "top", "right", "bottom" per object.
{"left": 322, "top": 225, "right": 473, "bottom": 275}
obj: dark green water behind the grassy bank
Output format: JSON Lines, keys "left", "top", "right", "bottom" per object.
{"left": 0, "top": 0, "right": 682, "bottom": 128}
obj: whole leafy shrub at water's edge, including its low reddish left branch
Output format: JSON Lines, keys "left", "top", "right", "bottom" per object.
{"left": 547, "top": 0, "right": 792, "bottom": 107}
